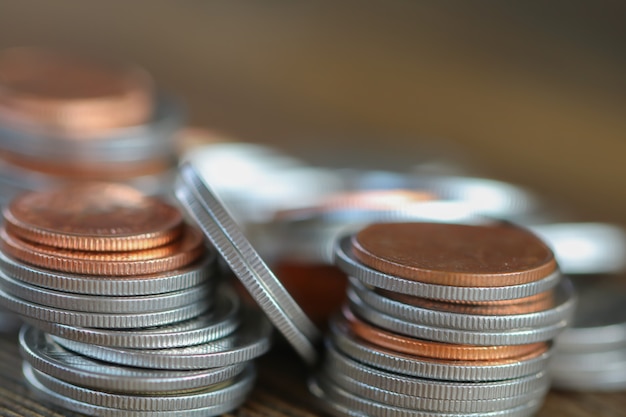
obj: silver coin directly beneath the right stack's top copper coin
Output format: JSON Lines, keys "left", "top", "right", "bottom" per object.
{"left": 335, "top": 236, "right": 561, "bottom": 301}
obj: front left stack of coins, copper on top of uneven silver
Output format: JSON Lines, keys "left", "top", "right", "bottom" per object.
{"left": 0, "top": 183, "right": 271, "bottom": 416}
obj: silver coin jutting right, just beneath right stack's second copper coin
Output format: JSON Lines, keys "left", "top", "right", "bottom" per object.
{"left": 349, "top": 277, "right": 576, "bottom": 331}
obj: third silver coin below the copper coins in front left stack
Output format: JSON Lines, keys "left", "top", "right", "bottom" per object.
{"left": 0, "top": 289, "right": 208, "bottom": 329}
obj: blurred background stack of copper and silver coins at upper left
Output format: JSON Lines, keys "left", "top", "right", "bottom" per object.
{"left": 0, "top": 47, "right": 182, "bottom": 205}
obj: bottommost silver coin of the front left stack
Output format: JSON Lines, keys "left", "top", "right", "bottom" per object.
{"left": 24, "top": 367, "right": 246, "bottom": 417}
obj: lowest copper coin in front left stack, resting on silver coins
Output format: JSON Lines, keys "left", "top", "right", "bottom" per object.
{"left": 0, "top": 227, "right": 205, "bottom": 276}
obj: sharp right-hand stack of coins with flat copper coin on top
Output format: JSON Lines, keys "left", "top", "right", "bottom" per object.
{"left": 310, "top": 223, "right": 575, "bottom": 416}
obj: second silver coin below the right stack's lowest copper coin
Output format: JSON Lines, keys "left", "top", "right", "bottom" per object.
{"left": 323, "top": 343, "right": 548, "bottom": 401}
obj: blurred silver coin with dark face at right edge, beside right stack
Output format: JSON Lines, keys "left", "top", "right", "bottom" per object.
{"left": 556, "top": 275, "right": 626, "bottom": 353}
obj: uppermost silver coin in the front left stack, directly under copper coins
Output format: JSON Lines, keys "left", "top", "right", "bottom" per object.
{"left": 0, "top": 247, "right": 216, "bottom": 296}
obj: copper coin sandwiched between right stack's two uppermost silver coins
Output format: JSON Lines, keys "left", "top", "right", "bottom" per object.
{"left": 376, "top": 289, "right": 554, "bottom": 316}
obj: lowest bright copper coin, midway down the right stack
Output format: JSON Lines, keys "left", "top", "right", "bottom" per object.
{"left": 341, "top": 306, "right": 547, "bottom": 361}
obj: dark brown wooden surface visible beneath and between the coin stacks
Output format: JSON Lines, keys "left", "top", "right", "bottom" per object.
{"left": 0, "top": 328, "right": 626, "bottom": 417}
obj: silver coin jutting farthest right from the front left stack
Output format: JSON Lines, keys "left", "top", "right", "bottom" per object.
{"left": 51, "top": 311, "right": 272, "bottom": 370}
